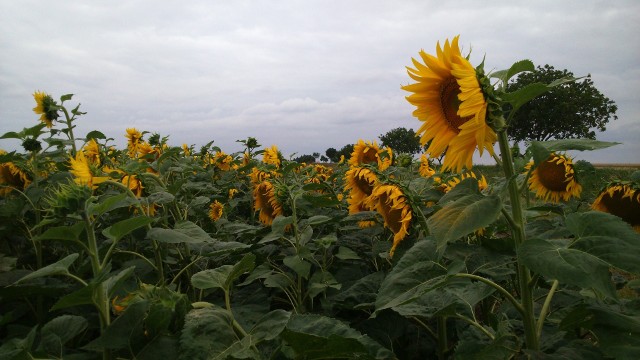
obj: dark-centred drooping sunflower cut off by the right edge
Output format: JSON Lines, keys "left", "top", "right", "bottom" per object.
{"left": 591, "top": 182, "right": 640, "bottom": 233}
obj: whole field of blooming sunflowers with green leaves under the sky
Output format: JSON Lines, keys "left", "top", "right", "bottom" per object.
{"left": 0, "top": 37, "right": 640, "bottom": 360}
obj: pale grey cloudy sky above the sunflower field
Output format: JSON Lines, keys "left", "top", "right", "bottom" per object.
{"left": 0, "top": 0, "right": 640, "bottom": 163}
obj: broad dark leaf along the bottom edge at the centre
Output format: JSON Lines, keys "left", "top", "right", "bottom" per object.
{"left": 282, "top": 315, "right": 394, "bottom": 360}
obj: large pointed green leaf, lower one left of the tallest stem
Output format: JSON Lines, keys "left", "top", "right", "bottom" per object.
{"left": 375, "top": 238, "right": 446, "bottom": 313}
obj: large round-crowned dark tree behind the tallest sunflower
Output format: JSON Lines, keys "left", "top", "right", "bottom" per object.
{"left": 507, "top": 65, "right": 618, "bottom": 142}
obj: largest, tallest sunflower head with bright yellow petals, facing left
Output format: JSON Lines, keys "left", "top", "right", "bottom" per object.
{"left": 402, "top": 36, "right": 497, "bottom": 172}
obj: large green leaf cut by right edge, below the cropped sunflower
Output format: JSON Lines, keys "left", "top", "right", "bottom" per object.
{"left": 566, "top": 211, "right": 640, "bottom": 274}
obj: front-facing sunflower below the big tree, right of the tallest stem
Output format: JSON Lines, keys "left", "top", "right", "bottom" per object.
{"left": 525, "top": 153, "right": 582, "bottom": 203}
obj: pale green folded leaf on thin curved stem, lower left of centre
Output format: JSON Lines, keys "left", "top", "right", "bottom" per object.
{"left": 191, "top": 253, "right": 256, "bottom": 292}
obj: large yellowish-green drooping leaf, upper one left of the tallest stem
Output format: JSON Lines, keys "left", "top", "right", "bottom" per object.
{"left": 427, "top": 194, "right": 502, "bottom": 252}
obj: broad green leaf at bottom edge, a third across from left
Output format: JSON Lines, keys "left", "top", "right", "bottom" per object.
{"left": 179, "top": 307, "right": 237, "bottom": 360}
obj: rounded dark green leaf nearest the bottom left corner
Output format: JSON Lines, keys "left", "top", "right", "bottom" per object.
{"left": 38, "top": 315, "right": 89, "bottom": 355}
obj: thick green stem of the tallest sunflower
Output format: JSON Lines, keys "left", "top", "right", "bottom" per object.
{"left": 497, "top": 130, "right": 538, "bottom": 350}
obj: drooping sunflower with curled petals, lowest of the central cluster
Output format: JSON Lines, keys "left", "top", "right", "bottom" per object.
{"left": 369, "top": 185, "right": 412, "bottom": 256}
